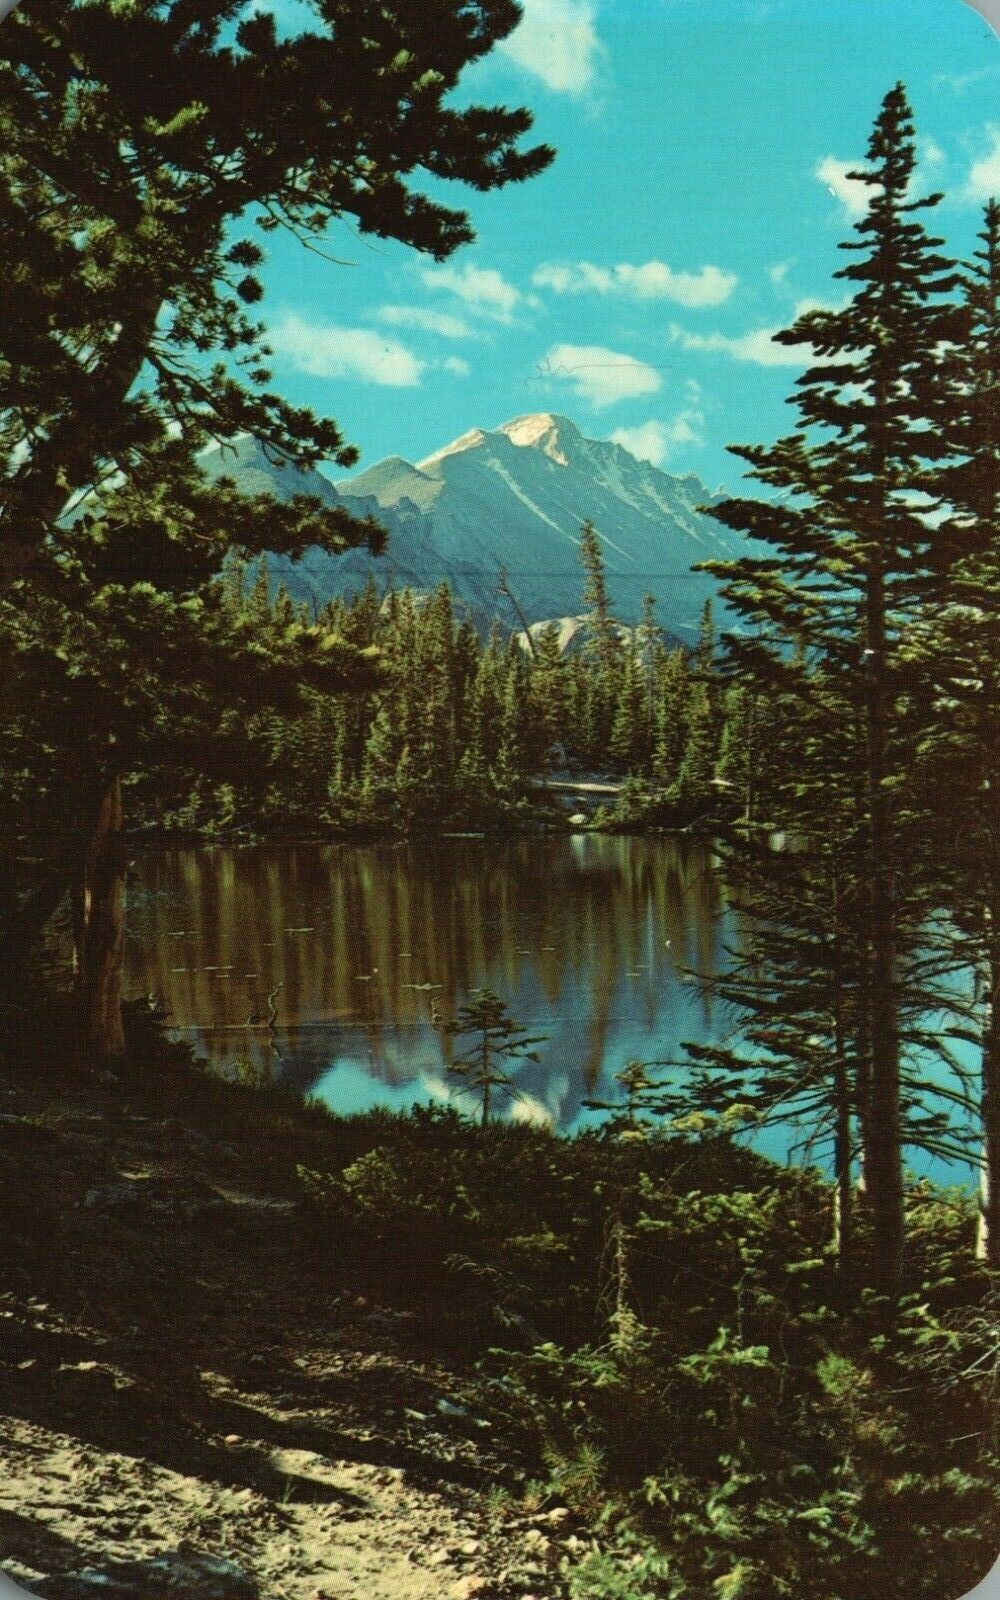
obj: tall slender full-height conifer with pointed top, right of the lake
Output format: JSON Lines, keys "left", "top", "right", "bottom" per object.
{"left": 697, "top": 85, "right": 960, "bottom": 1299}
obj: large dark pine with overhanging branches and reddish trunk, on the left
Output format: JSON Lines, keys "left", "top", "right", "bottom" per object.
{"left": 0, "top": 0, "right": 550, "bottom": 1053}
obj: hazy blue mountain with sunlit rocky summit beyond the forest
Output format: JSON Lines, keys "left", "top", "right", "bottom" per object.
{"left": 203, "top": 411, "right": 739, "bottom": 638}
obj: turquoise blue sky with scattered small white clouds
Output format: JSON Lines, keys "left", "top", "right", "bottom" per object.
{"left": 259, "top": 0, "right": 1000, "bottom": 488}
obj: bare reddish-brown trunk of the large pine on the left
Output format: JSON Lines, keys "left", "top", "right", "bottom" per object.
{"left": 74, "top": 774, "right": 125, "bottom": 1061}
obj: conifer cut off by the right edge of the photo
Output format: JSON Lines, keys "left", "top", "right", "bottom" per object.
{"left": 907, "top": 202, "right": 1000, "bottom": 1267}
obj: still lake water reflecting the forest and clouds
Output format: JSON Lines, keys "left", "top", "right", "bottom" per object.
{"left": 126, "top": 834, "right": 968, "bottom": 1181}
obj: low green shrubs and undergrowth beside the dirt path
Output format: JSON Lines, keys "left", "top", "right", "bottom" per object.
{"left": 292, "top": 1110, "right": 1000, "bottom": 1600}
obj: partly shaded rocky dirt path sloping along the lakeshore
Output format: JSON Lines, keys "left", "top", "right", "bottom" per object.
{"left": 0, "top": 1067, "right": 584, "bottom": 1600}
